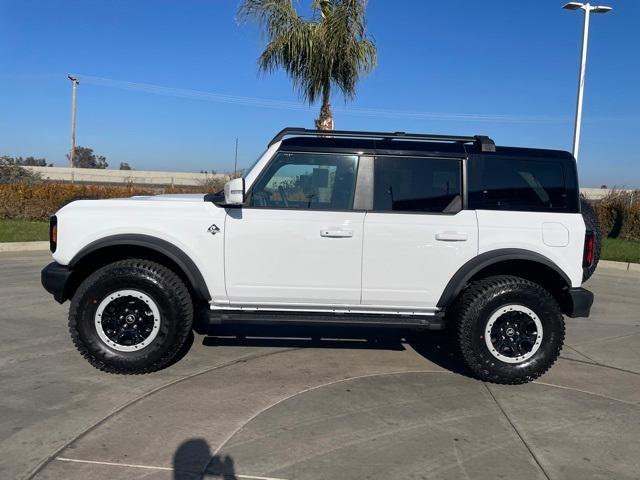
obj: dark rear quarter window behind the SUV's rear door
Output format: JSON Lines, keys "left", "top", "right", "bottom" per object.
{"left": 469, "top": 157, "right": 568, "bottom": 211}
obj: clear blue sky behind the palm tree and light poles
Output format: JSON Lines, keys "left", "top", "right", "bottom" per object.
{"left": 0, "top": 0, "right": 640, "bottom": 187}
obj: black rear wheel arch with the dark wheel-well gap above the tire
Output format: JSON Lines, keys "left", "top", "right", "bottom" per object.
{"left": 437, "top": 248, "right": 571, "bottom": 310}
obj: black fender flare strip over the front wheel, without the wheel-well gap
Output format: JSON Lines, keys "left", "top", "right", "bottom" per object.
{"left": 69, "top": 233, "right": 211, "bottom": 302}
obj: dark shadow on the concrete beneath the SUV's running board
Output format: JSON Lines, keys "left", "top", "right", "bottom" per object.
{"left": 202, "top": 325, "right": 471, "bottom": 376}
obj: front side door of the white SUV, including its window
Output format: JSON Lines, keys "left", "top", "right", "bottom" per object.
{"left": 225, "top": 152, "right": 365, "bottom": 308}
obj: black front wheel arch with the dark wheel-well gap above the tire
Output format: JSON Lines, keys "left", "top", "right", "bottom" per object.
{"left": 65, "top": 234, "right": 211, "bottom": 302}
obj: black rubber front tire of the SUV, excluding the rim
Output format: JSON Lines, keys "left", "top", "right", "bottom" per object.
{"left": 69, "top": 259, "right": 193, "bottom": 375}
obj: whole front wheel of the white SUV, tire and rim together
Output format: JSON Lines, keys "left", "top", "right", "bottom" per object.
{"left": 69, "top": 259, "right": 193, "bottom": 374}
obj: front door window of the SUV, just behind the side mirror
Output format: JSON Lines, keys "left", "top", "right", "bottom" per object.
{"left": 249, "top": 152, "right": 358, "bottom": 210}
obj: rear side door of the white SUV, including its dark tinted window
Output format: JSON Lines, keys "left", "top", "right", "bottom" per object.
{"left": 362, "top": 156, "right": 478, "bottom": 312}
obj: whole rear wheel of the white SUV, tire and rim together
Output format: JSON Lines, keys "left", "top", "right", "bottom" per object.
{"left": 453, "top": 275, "right": 564, "bottom": 384}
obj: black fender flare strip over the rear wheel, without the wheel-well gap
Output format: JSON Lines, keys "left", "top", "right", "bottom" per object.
{"left": 437, "top": 248, "right": 571, "bottom": 308}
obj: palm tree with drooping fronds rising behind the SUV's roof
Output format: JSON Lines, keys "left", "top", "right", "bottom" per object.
{"left": 238, "top": 0, "right": 377, "bottom": 130}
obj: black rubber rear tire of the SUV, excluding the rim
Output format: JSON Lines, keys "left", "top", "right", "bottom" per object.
{"left": 450, "top": 275, "right": 565, "bottom": 384}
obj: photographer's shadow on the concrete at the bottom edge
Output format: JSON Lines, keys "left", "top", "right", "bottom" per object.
{"left": 173, "top": 438, "right": 238, "bottom": 480}
